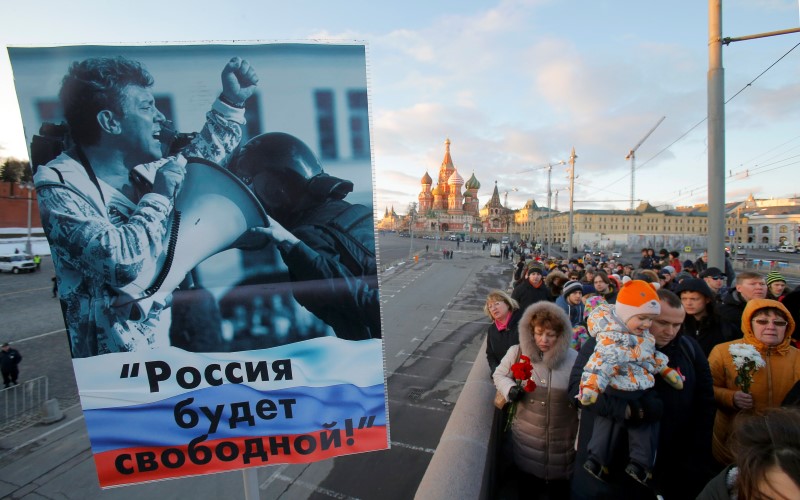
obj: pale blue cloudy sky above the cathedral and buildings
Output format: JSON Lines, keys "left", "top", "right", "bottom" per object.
{"left": 0, "top": 0, "right": 800, "bottom": 213}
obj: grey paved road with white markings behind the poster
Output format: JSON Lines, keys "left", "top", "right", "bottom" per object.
{"left": 0, "top": 240, "right": 511, "bottom": 499}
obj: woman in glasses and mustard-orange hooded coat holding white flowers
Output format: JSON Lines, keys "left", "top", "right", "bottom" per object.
{"left": 708, "top": 299, "right": 800, "bottom": 465}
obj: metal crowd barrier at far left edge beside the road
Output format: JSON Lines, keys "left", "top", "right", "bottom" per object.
{"left": 0, "top": 377, "right": 49, "bottom": 434}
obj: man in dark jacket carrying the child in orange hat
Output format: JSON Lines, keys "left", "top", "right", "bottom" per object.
{"left": 569, "top": 290, "right": 716, "bottom": 500}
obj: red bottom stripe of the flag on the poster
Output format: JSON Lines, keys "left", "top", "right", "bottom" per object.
{"left": 94, "top": 426, "right": 388, "bottom": 488}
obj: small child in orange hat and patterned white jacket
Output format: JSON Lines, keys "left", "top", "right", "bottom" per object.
{"left": 578, "top": 280, "right": 683, "bottom": 484}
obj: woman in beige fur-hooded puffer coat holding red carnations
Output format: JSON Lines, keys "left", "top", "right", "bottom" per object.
{"left": 493, "top": 301, "right": 578, "bottom": 498}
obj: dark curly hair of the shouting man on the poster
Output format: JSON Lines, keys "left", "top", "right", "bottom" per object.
{"left": 58, "top": 57, "right": 153, "bottom": 146}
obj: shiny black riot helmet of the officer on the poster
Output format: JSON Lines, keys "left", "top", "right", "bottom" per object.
{"left": 229, "top": 132, "right": 353, "bottom": 224}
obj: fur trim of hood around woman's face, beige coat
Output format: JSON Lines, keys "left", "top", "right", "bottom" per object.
{"left": 519, "top": 301, "right": 572, "bottom": 370}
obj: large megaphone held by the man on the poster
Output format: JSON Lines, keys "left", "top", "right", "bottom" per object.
{"left": 113, "top": 158, "right": 269, "bottom": 321}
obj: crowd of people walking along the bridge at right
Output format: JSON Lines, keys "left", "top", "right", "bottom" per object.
{"left": 484, "top": 249, "right": 800, "bottom": 500}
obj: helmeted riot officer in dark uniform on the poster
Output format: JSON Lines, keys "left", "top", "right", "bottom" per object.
{"left": 229, "top": 132, "right": 381, "bottom": 340}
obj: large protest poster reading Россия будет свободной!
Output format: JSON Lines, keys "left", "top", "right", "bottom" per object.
{"left": 8, "top": 43, "right": 389, "bottom": 488}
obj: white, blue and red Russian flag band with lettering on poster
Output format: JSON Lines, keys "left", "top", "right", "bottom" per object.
{"left": 73, "top": 337, "right": 388, "bottom": 487}
